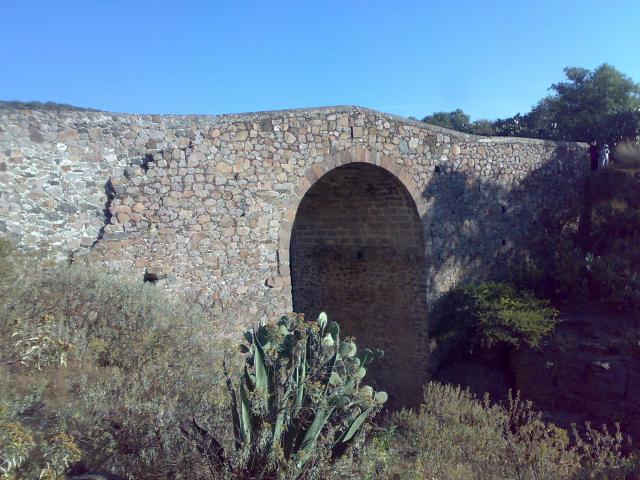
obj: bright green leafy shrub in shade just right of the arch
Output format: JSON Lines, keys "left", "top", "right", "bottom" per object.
{"left": 435, "top": 282, "right": 557, "bottom": 350}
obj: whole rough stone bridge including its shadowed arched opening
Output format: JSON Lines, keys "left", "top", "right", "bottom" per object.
{"left": 0, "top": 106, "right": 589, "bottom": 403}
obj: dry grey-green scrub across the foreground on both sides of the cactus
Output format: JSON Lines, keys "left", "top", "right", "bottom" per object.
{"left": 0, "top": 242, "right": 635, "bottom": 480}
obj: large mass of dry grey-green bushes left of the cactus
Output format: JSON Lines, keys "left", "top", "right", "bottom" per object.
{"left": 0, "top": 244, "right": 227, "bottom": 478}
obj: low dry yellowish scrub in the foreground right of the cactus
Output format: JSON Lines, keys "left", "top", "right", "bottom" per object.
{"left": 393, "top": 383, "right": 637, "bottom": 480}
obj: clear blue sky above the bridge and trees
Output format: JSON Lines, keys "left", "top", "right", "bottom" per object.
{"left": 0, "top": 0, "right": 640, "bottom": 120}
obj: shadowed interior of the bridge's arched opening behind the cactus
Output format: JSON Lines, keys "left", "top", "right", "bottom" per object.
{"left": 290, "top": 163, "right": 428, "bottom": 406}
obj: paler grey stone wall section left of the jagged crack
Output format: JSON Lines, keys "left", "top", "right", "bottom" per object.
{"left": 0, "top": 107, "right": 136, "bottom": 254}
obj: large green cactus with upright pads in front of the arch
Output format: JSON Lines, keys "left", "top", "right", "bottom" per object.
{"left": 182, "top": 313, "right": 387, "bottom": 478}
